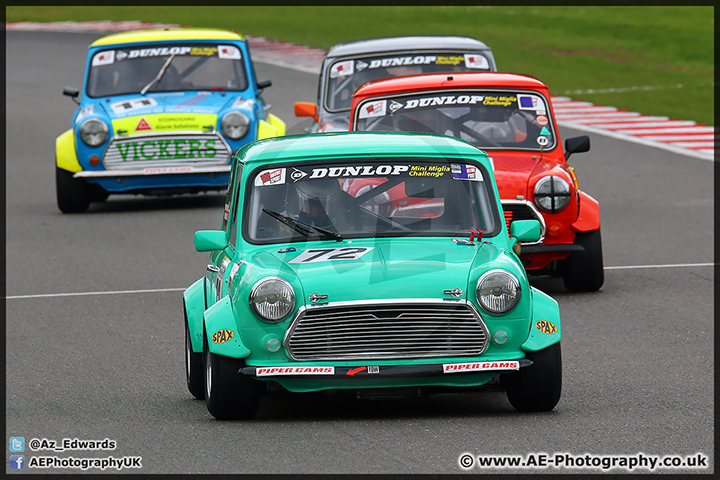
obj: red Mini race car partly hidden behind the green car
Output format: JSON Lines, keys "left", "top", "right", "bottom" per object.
{"left": 350, "top": 72, "right": 604, "bottom": 292}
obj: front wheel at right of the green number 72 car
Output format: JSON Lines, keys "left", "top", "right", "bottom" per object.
{"left": 500, "top": 342, "right": 562, "bottom": 412}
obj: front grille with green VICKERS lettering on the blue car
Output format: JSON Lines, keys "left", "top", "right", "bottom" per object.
{"left": 102, "top": 132, "right": 232, "bottom": 170}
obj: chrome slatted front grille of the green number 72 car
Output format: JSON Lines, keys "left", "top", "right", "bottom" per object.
{"left": 285, "top": 299, "right": 488, "bottom": 361}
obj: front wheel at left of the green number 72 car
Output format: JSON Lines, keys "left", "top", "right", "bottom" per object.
{"left": 203, "top": 336, "right": 260, "bottom": 420}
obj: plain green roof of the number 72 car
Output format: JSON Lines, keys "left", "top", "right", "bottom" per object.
{"left": 236, "top": 132, "right": 489, "bottom": 166}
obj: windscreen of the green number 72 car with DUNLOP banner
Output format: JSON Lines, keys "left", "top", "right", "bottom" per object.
{"left": 243, "top": 158, "right": 501, "bottom": 244}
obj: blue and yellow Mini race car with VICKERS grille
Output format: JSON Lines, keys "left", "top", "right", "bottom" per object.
{"left": 55, "top": 28, "right": 285, "bottom": 213}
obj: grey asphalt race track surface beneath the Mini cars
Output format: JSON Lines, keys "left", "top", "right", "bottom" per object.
{"left": 6, "top": 32, "right": 714, "bottom": 474}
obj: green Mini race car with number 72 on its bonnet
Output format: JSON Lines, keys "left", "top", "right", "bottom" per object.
{"left": 183, "top": 132, "right": 562, "bottom": 419}
